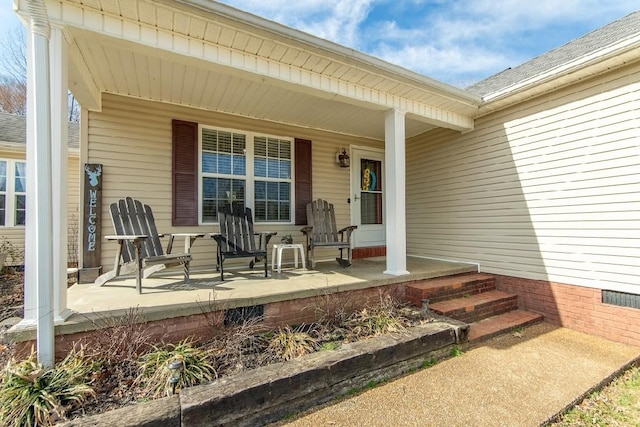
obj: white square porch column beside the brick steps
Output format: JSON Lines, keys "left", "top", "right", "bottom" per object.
{"left": 384, "top": 109, "right": 409, "bottom": 276}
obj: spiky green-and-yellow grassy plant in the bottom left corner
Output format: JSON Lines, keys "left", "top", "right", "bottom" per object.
{"left": 0, "top": 349, "right": 94, "bottom": 427}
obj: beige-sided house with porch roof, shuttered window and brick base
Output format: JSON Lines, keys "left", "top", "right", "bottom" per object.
{"left": 13, "top": 0, "right": 640, "bottom": 345}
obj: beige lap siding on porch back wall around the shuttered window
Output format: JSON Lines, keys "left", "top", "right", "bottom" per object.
{"left": 88, "top": 94, "right": 382, "bottom": 268}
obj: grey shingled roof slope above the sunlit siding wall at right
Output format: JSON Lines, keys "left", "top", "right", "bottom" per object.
{"left": 466, "top": 11, "right": 640, "bottom": 97}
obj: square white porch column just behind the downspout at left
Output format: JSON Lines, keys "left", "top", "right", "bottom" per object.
{"left": 49, "top": 27, "right": 71, "bottom": 321}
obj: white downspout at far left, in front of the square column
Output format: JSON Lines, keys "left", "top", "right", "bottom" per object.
{"left": 25, "top": 0, "right": 54, "bottom": 366}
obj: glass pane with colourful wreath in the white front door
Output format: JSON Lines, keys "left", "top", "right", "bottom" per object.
{"left": 360, "top": 159, "right": 382, "bottom": 224}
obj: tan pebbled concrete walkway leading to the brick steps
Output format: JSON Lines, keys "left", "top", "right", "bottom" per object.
{"left": 282, "top": 323, "right": 640, "bottom": 427}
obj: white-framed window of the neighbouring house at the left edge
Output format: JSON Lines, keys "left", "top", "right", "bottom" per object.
{"left": 0, "top": 160, "right": 27, "bottom": 227}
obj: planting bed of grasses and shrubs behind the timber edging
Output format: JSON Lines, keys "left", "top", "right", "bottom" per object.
{"left": 0, "top": 286, "right": 415, "bottom": 426}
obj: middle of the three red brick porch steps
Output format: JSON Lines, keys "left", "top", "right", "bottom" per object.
{"left": 429, "top": 291, "right": 518, "bottom": 323}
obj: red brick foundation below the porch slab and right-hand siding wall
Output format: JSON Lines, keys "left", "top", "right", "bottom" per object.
{"left": 13, "top": 275, "right": 640, "bottom": 358}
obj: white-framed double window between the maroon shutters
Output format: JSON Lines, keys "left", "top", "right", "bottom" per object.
{"left": 200, "top": 127, "right": 293, "bottom": 223}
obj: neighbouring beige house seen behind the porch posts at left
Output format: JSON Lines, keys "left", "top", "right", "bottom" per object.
{"left": 0, "top": 113, "right": 80, "bottom": 265}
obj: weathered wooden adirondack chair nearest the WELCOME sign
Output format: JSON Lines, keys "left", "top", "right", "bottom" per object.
{"left": 95, "top": 197, "right": 204, "bottom": 293}
